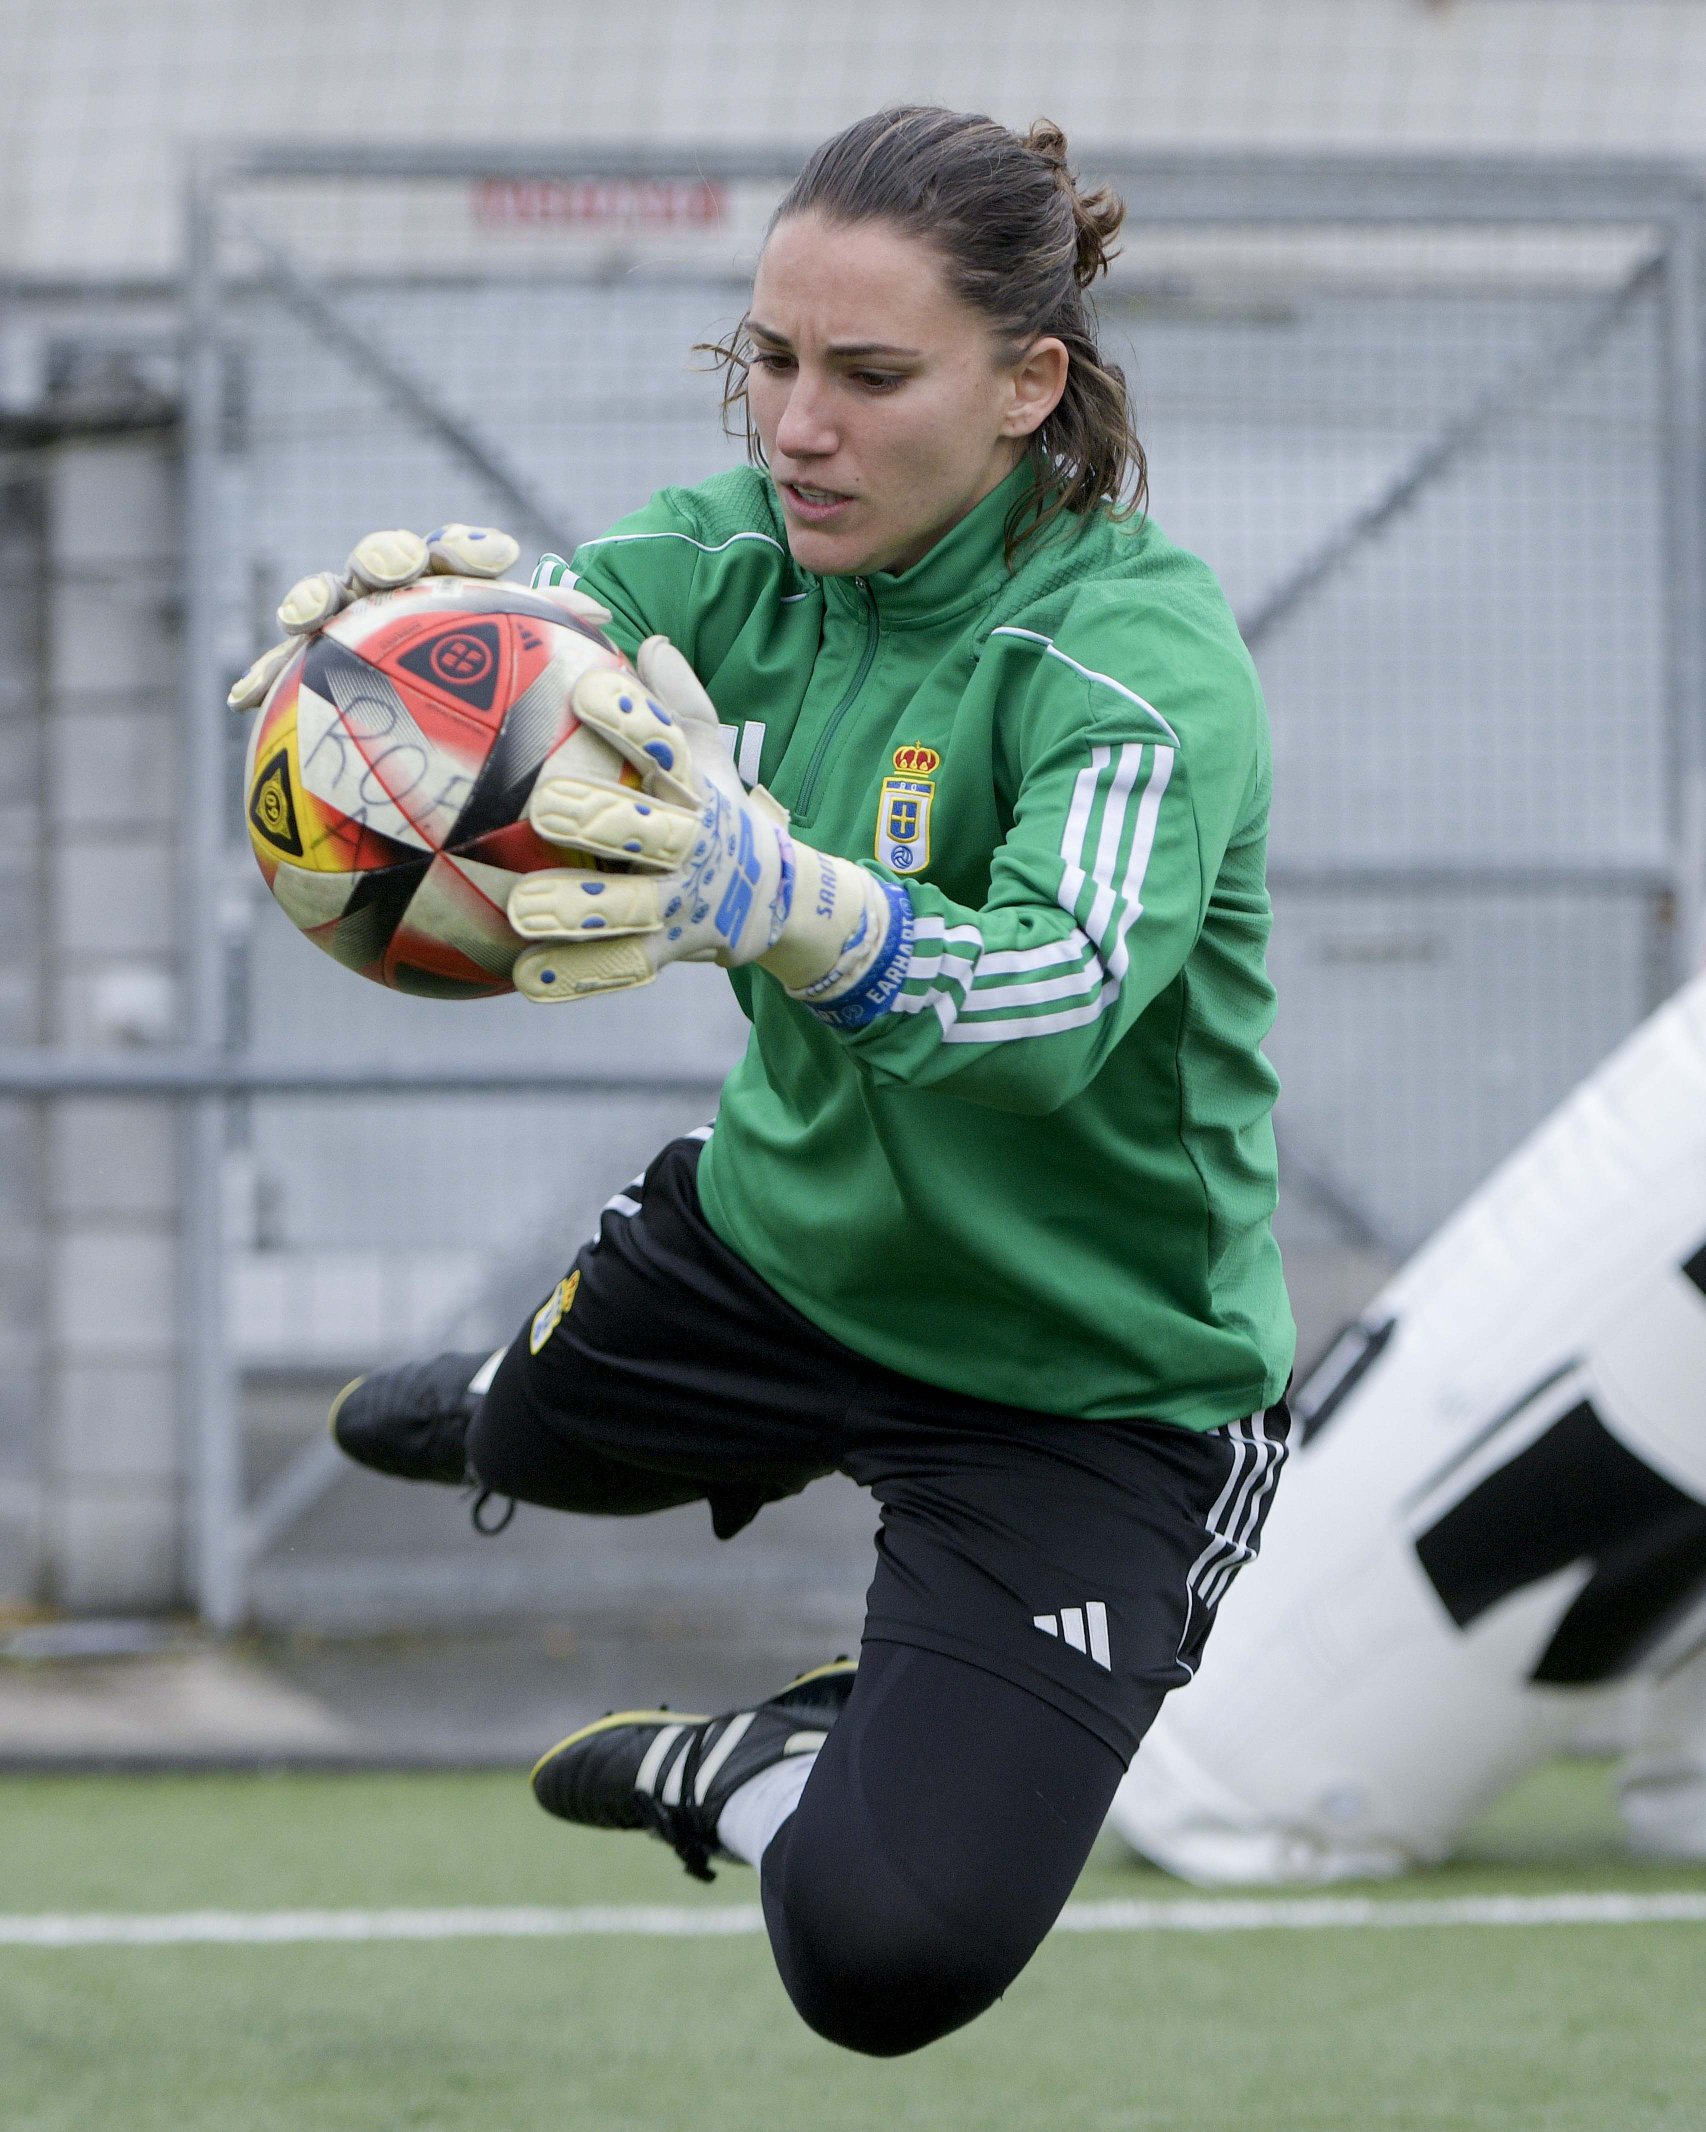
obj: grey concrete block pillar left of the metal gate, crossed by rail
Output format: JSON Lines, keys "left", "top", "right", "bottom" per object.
{"left": 38, "top": 431, "right": 186, "bottom": 1610}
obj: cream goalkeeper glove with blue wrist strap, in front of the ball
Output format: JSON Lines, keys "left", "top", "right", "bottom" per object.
{"left": 510, "top": 637, "right": 913, "bottom": 1028}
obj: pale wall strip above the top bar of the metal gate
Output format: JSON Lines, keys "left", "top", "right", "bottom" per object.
{"left": 0, "top": 0, "right": 1706, "bottom": 294}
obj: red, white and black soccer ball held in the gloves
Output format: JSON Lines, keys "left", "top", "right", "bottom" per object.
{"left": 243, "top": 578, "right": 640, "bottom": 1000}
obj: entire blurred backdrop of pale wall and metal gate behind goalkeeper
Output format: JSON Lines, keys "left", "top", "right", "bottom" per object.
{"left": 0, "top": 0, "right": 1706, "bottom": 1697}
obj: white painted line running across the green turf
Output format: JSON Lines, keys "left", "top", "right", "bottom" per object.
{"left": 0, "top": 1893, "right": 1706, "bottom": 1947}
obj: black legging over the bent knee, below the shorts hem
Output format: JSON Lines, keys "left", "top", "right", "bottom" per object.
{"left": 763, "top": 1642, "right": 1122, "bottom": 2057}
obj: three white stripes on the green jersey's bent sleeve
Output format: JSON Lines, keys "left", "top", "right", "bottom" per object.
{"left": 896, "top": 742, "right": 1175, "bottom": 1045}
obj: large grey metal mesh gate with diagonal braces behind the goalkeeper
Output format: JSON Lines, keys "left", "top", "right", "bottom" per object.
{"left": 126, "top": 149, "right": 1706, "bottom": 1622}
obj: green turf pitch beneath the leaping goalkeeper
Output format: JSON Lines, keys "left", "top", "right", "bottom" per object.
{"left": 0, "top": 1763, "right": 1706, "bottom": 2132}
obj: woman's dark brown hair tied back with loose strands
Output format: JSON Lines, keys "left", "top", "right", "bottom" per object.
{"left": 710, "top": 104, "right": 1147, "bottom": 559}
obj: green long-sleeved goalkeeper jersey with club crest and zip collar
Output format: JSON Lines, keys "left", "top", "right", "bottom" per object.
{"left": 558, "top": 469, "right": 1294, "bottom": 1428}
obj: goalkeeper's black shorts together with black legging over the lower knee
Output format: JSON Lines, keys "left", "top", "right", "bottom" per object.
{"left": 467, "top": 1141, "right": 1288, "bottom": 2057}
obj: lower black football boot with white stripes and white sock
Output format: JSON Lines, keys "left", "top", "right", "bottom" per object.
{"left": 533, "top": 1659, "right": 857, "bottom": 1880}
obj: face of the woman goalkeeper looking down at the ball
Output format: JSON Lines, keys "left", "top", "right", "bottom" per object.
{"left": 746, "top": 213, "right": 1068, "bottom": 578}
